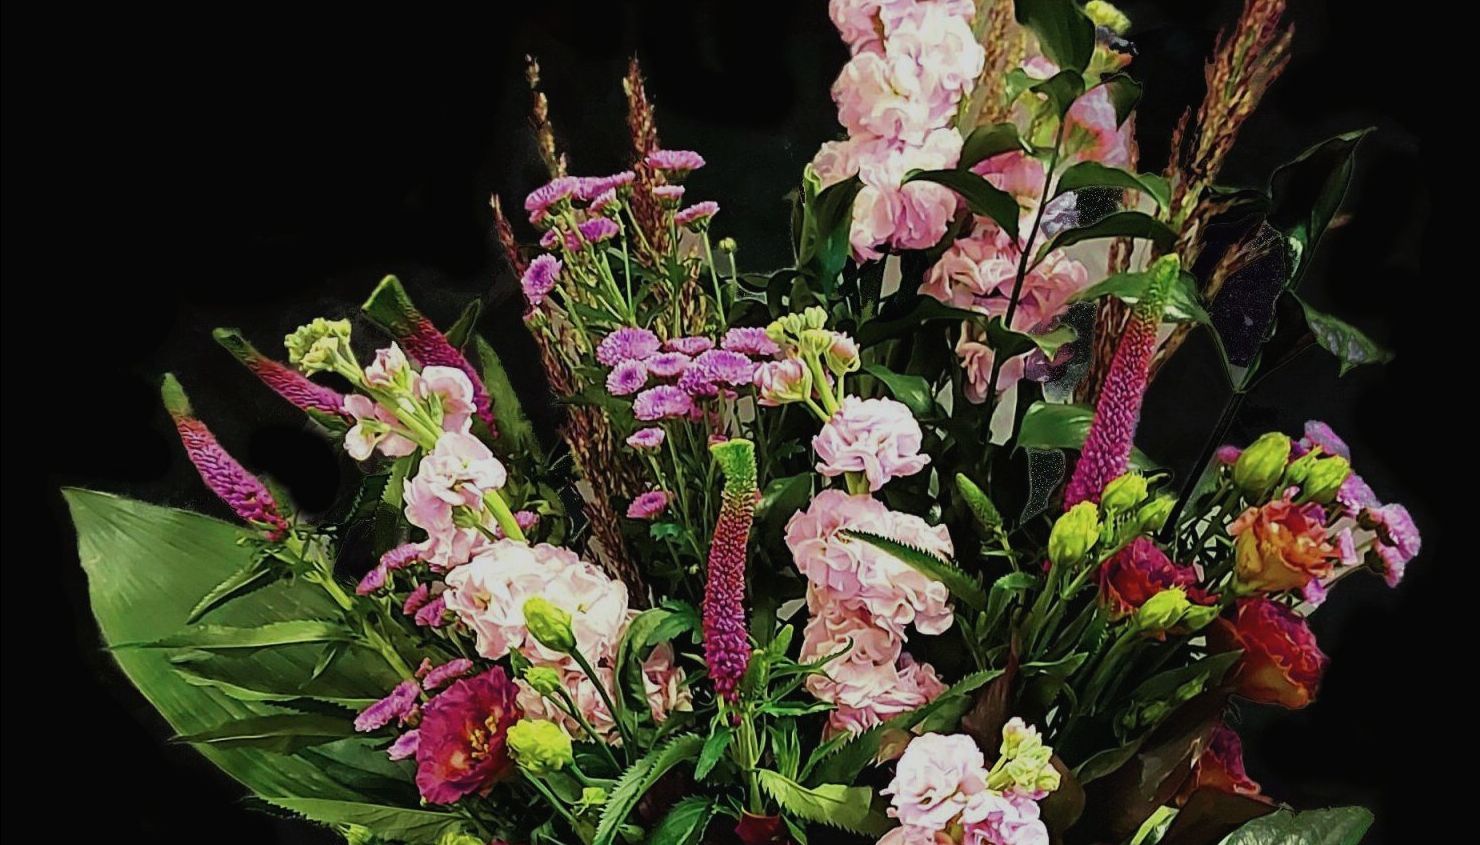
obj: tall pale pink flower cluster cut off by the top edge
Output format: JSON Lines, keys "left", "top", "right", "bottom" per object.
{"left": 813, "top": 0, "right": 986, "bottom": 260}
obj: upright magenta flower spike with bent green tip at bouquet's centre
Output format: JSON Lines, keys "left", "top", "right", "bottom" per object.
{"left": 703, "top": 438, "right": 758, "bottom": 701}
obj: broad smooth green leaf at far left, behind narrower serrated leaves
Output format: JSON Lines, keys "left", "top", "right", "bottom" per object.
{"left": 62, "top": 488, "right": 400, "bottom": 801}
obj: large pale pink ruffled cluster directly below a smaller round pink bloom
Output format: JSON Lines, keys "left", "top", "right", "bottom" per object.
{"left": 786, "top": 490, "right": 955, "bottom": 733}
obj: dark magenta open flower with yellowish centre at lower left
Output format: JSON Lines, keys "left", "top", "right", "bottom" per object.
{"left": 416, "top": 667, "right": 522, "bottom": 804}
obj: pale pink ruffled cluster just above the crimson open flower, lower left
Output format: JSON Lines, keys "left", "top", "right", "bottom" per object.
{"left": 443, "top": 540, "right": 691, "bottom": 740}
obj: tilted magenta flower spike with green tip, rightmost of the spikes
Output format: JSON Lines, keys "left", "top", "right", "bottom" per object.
{"left": 1064, "top": 255, "right": 1181, "bottom": 509}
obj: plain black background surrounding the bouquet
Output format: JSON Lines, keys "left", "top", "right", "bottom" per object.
{"left": 3, "top": 0, "right": 1432, "bottom": 844}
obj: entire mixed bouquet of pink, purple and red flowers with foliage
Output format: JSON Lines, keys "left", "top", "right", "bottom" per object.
{"left": 67, "top": 0, "right": 1419, "bottom": 845}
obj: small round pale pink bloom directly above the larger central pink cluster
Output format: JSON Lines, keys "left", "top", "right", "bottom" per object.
{"left": 813, "top": 397, "right": 929, "bottom": 491}
